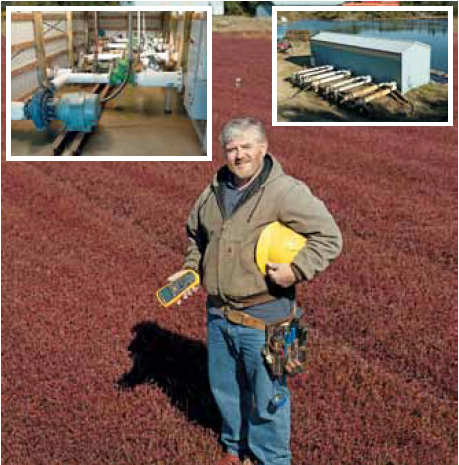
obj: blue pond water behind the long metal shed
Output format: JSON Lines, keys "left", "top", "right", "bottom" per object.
{"left": 277, "top": 18, "right": 448, "bottom": 72}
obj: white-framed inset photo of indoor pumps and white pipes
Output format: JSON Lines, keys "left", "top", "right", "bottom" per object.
{"left": 6, "top": 4, "right": 212, "bottom": 161}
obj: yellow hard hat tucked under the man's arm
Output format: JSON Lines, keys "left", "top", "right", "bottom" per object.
{"left": 257, "top": 221, "right": 306, "bottom": 274}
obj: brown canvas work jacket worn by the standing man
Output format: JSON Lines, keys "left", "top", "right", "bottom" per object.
{"left": 184, "top": 154, "right": 342, "bottom": 308}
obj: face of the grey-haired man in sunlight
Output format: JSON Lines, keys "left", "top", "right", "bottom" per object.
{"left": 223, "top": 130, "right": 267, "bottom": 186}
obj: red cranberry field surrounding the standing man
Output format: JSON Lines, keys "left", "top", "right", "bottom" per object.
{"left": 2, "top": 29, "right": 457, "bottom": 465}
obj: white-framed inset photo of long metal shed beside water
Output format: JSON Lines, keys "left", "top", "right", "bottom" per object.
{"left": 272, "top": 5, "right": 454, "bottom": 126}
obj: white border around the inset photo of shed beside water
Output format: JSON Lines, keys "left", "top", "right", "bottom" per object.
{"left": 272, "top": 5, "right": 454, "bottom": 127}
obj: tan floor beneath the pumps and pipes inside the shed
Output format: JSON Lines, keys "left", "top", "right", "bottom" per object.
{"left": 11, "top": 86, "right": 204, "bottom": 157}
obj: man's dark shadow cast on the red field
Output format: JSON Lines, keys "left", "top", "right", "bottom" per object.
{"left": 118, "top": 321, "right": 221, "bottom": 434}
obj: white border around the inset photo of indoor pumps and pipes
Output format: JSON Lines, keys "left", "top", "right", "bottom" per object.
{"left": 5, "top": 5, "right": 212, "bottom": 161}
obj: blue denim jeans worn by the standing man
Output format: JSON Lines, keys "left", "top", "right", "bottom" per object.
{"left": 207, "top": 315, "right": 291, "bottom": 465}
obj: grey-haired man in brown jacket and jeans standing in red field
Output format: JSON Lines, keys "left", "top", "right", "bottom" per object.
{"left": 171, "top": 118, "right": 342, "bottom": 465}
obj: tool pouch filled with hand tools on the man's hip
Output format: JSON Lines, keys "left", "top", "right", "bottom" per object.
{"left": 262, "top": 306, "right": 307, "bottom": 376}
